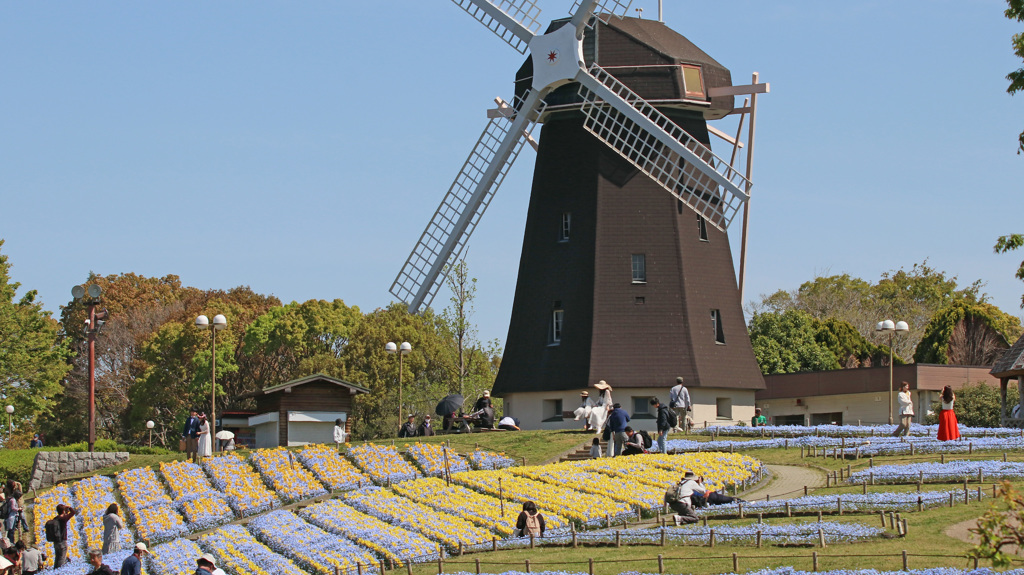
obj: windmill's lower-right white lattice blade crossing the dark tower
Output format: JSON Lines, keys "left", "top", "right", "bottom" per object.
{"left": 577, "top": 64, "right": 750, "bottom": 231}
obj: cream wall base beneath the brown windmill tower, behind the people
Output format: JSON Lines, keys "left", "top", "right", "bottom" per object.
{"left": 503, "top": 388, "right": 754, "bottom": 431}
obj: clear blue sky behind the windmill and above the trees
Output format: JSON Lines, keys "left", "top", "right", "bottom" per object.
{"left": 0, "top": 0, "right": 1024, "bottom": 341}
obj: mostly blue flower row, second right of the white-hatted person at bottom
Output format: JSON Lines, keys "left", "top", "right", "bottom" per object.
{"left": 249, "top": 511, "right": 375, "bottom": 575}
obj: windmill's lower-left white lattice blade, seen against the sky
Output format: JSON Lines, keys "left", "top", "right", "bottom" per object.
{"left": 390, "top": 92, "right": 545, "bottom": 313}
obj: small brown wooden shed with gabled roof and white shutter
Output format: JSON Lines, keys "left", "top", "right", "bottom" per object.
{"left": 239, "top": 373, "right": 370, "bottom": 448}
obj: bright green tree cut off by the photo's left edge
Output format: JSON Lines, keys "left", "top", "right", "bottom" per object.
{"left": 0, "top": 239, "right": 71, "bottom": 435}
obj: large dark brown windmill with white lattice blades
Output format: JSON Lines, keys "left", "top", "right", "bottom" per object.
{"left": 390, "top": 0, "right": 767, "bottom": 421}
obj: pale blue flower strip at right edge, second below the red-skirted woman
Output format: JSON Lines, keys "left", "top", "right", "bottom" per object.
{"left": 849, "top": 459, "right": 1024, "bottom": 483}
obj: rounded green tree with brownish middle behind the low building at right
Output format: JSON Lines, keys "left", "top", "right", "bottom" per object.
{"left": 913, "top": 301, "right": 1021, "bottom": 365}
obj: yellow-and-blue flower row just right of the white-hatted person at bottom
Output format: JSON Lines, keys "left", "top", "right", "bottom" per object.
{"left": 199, "top": 525, "right": 305, "bottom": 575}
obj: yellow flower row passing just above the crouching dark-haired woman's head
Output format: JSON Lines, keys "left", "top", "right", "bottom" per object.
{"left": 452, "top": 471, "right": 636, "bottom": 526}
